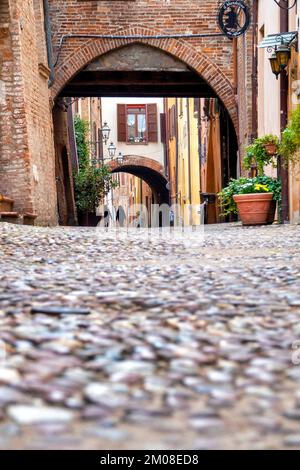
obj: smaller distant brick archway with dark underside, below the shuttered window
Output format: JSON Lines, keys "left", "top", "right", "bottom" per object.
{"left": 108, "top": 155, "right": 169, "bottom": 204}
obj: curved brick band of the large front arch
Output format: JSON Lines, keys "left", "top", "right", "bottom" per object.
{"left": 52, "top": 27, "right": 238, "bottom": 132}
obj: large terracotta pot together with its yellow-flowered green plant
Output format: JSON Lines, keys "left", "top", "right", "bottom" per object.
{"left": 218, "top": 176, "right": 281, "bottom": 225}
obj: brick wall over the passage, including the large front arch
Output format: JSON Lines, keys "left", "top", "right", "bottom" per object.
{"left": 49, "top": 0, "right": 238, "bottom": 129}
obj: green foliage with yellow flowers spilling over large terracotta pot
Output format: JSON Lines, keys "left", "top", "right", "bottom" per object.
{"left": 218, "top": 175, "right": 281, "bottom": 216}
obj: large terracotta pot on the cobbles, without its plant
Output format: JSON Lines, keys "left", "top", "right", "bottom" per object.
{"left": 233, "top": 193, "right": 273, "bottom": 225}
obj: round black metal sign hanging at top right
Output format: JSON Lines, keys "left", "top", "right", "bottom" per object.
{"left": 218, "top": 0, "right": 251, "bottom": 38}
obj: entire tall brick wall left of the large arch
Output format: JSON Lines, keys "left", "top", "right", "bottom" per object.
{"left": 0, "top": 0, "right": 57, "bottom": 225}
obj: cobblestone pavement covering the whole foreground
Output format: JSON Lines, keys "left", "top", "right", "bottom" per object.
{"left": 0, "top": 223, "right": 300, "bottom": 449}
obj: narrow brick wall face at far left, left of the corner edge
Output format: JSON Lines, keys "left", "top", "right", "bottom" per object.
{"left": 0, "top": 0, "right": 32, "bottom": 215}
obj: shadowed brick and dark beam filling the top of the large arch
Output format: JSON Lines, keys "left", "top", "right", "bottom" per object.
{"left": 61, "top": 43, "right": 217, "bottom": 98}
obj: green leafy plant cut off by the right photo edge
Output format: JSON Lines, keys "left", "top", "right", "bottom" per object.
{"left": 279, "top": 106, "right": 300, "bottom": 166}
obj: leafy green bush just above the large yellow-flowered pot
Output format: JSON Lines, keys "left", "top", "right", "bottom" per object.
{"left": 243, "top": 134, "right": 279, "bottom": 176}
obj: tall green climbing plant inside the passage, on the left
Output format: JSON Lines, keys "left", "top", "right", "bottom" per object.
{"left": 74, "top": 116, "right": 118, "bottom": 212}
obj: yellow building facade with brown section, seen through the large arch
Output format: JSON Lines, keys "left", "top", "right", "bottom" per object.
{"left": 165, "top": 98, "right": 238, "bottom": 225}
